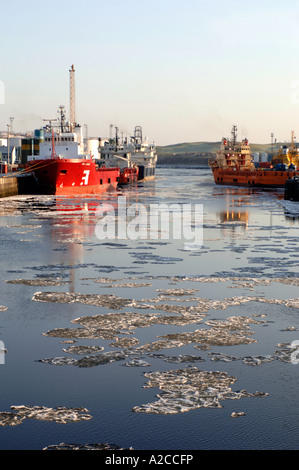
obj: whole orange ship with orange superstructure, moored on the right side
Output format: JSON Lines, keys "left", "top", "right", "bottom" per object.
{"left": 209, "top": 126, "right": 299, "bottom": 188}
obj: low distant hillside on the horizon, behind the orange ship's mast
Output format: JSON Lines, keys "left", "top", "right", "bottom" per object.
{"left": 157, "top": 142, "right": 283, "bottom": 166}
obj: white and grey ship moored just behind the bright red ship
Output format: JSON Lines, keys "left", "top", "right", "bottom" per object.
{"left": 99, "top": 126, "right": 157, "bottom": 184}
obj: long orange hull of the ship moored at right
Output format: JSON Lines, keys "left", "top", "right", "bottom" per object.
{"left": 212, "top": 168, "right": 299, "bottom": 188}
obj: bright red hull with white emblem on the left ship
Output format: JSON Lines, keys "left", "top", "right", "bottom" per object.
{"left": 28, "top": 158, "right": 119, "bottom": 195}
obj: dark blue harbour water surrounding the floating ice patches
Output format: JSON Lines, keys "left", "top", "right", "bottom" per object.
{"left": 0, "top": 169, "right": 299, "bottom": 450}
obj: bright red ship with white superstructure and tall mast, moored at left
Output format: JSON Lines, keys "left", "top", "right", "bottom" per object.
{"left": 26, "top": 66, "right": 120, "bottom": 195}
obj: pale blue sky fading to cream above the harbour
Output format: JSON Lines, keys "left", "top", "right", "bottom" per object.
{"left": 0, "top": 0, "right": 299, "bottom": 145}
